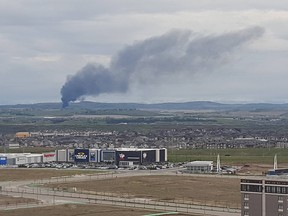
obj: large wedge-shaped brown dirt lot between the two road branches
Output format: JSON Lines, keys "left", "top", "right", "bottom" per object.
{"left": 49, "top": 175, "right": 240, "bottom": 208}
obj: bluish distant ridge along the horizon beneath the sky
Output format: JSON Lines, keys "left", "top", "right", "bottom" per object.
{"left": 0, "top": 101, "right": 288, "bottom": 111}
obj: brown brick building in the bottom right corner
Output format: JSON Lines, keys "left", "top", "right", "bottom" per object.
{"left": 241, "top": 177, "right": 288, "bottom": 216}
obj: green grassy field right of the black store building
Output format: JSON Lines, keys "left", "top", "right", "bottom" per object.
{"left": 168, "top": 148, "right": 288, "bottom": 165}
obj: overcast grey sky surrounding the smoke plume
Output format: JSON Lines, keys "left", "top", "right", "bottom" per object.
{"left": 0, "top": 0, "right": 288, "bottom": 104}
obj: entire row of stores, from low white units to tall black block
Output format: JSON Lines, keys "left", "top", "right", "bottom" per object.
{"left": 0, "top": 148, "right": 167, "bottom": 167}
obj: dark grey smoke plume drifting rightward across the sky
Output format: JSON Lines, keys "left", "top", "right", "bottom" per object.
{"left": 61, "top": 27, "right": 264, "bottom": 107}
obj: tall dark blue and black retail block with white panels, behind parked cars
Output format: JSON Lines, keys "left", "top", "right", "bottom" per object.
{"left": 55, "top": 148, "right": 167, "bottom": 167}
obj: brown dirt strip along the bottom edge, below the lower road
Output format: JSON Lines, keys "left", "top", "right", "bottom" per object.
{"left": 0, "top": 204, "right": 194, "bottom": 216}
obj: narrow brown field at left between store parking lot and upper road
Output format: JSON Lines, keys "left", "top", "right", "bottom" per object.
{"left": 0, "top": 168, "right": 100, "bottom": 181}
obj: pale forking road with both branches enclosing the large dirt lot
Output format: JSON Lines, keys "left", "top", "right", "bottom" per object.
{"left": 0, "top": 170, "right": 240, "bottom": 216}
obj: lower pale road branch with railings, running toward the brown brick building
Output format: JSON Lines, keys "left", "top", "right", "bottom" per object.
{"left": 1, "top": 184, "right": 240, "bottom": 216}
